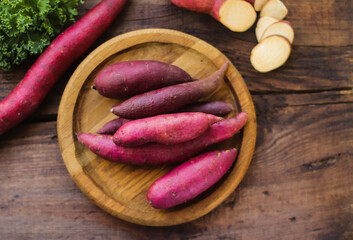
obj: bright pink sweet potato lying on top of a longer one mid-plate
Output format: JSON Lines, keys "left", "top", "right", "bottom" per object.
{"left": 113, "top": 113, "right": 222, "bottom": 147}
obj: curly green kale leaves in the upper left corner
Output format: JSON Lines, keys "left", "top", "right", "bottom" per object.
{"left": 0, "top": 0, "right": 82, "bottom": 70}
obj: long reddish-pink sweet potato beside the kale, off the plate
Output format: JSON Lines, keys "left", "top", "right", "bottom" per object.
{"left": 0, "top": 0, "right": 127, "bottom": 134}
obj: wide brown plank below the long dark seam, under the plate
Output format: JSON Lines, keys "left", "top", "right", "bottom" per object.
{"left": 0, "top": 91, "right": 353, "bottom": 240}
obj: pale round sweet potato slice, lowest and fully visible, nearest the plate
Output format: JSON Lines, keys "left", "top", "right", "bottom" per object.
{"left": 250, "top": 35, "right": 291, "bottom": 72}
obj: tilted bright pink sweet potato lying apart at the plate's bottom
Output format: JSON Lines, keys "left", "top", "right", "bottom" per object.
{"left": 147, "top": 148, "right": 237, "bottom": 209}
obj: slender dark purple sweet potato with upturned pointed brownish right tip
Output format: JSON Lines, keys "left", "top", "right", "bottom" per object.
{"left": 111, "top": 62, "right": 228, "bottom": 119}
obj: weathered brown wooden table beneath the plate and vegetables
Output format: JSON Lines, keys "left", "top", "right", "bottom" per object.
{"left": 0, "top": 0, "right": 353, "bottom": 240}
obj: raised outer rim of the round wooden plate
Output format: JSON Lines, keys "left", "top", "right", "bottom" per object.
{"left": 57, "top": 28, "right": 257, "bottom": 226}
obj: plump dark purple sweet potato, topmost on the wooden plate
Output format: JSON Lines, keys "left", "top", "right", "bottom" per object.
{"left": 94, "top": 60, "right": 193, "bottom": 98}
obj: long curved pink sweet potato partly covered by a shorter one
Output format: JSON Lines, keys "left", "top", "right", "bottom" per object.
{"left": 77, "top": 112, "right": 247, "bottom": 165}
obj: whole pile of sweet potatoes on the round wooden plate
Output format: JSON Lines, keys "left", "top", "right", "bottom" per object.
{"left": 77, "top": 61, "right": 247, "bottom": 209}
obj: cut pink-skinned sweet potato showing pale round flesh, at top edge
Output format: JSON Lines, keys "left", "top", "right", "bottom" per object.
{"left": 171, "top": 0, "right": 256, "bottom": 32}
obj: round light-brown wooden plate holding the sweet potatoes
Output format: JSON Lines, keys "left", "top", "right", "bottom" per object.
{"left": 58, "top": 29, "right": 256, "bottom": 226}
